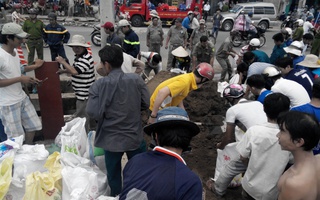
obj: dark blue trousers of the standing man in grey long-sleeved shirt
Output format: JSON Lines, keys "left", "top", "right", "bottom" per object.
{"left": 104, "top": 140, "right": 146, "bottom": 197}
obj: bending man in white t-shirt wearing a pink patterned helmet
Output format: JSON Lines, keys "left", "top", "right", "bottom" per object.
{"left": 206, "top": 84, "right": 267, "bottom": 196}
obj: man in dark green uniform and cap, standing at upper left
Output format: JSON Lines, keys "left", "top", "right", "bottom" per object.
{"left": 22, "top": 8, "right": 45, "bottom": 65}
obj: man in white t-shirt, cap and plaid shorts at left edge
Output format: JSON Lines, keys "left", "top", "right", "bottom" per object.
{"left": 0, "top": 23, "right": 43, "bottom": 144}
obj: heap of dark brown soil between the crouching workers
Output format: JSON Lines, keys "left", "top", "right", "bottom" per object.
{"left": 147, "top": 71, "right": 241, "bottom": 200}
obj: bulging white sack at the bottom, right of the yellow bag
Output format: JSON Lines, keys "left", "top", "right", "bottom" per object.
{"left": 61, "top": 152, "right": 110, "bottom": 200}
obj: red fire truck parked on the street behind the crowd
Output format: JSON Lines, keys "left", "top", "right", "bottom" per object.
{"left": 120, "top": 0, "right": 203, "bottom": 26}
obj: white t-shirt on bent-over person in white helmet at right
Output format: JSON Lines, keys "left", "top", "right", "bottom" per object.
{"left": 271, "top": 78, "right": 310, "bottom": 107}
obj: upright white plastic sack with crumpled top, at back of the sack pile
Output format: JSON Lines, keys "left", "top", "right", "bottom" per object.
{"left": 55, "top": 117, "right": 87, "bottom": 156}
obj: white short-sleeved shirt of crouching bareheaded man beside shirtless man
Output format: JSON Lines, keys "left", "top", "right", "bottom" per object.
{"left": 237, "top": 123, "right": 290, "bottom": 200}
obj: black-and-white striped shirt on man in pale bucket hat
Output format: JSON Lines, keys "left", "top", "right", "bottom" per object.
{"left": 72, "top": 51, "right": 95, "bottom": 101}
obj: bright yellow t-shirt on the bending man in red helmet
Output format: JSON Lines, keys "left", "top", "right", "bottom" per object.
{"left": 149, "top": 72, "right": 198, "bottom": 110}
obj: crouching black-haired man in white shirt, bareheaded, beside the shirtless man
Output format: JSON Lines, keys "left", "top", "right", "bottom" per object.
{"left": 236, "top": 93, "right": 290, "bottom": 199}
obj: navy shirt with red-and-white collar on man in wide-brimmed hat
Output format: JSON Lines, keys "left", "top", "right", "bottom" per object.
{"left": 120, "top": 147, "right": 202, "bottom": 200}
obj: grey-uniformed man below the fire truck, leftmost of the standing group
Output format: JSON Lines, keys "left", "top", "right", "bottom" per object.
{"left": 147, "top": 15, "right": 163, "bottom": 54}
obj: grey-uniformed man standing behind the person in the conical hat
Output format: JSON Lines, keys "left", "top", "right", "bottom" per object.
{"left": 165, "top": 18, "right": 188, "bottom": 71}
